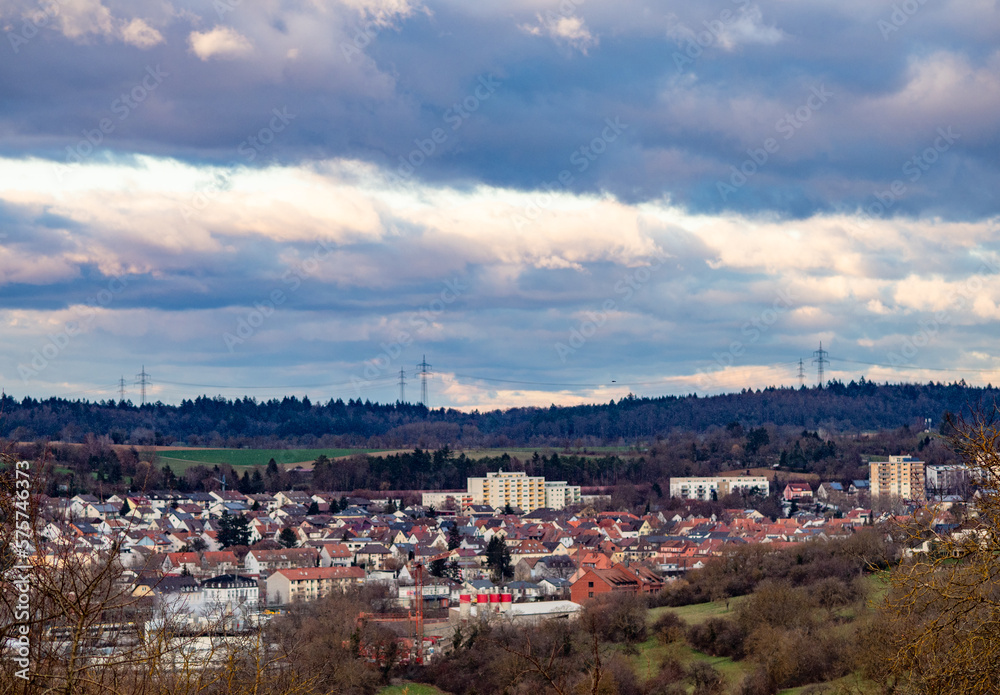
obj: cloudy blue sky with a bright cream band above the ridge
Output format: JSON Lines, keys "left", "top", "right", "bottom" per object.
{"left": 0, "top": 0, "right": 1000, "bottom": 410}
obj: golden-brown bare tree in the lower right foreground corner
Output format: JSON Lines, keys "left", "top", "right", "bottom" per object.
{"left": 867, "top": 405, "right": 1000, "bottom": 695}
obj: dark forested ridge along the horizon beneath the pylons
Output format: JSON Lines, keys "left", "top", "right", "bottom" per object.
{"left": 0, "top": 379, "right": 998, "bottom": 448}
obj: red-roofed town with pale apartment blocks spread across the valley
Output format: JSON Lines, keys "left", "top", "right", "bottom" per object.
{"left": 21, "top": 457, "right": 920, "bottom": 660}
